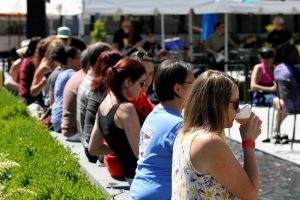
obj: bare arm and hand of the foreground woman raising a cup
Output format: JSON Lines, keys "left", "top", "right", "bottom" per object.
{"left": 191, "top": 114, "right": 261, "bottom": 200}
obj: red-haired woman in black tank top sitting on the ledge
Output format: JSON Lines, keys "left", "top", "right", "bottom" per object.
{"left": 89, "top": 58, "right": 146, "bottom": 183}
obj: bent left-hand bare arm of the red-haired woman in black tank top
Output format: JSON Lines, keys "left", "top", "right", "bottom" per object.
{"left": 89, "top": 112, "right": 114, "bottom": 156}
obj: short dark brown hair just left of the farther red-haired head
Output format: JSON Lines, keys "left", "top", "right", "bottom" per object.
{"left": 88, "top": 42, "right": 110, "bottom": 67}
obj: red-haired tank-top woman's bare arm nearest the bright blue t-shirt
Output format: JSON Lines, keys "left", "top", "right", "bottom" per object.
{"left": 115, "top": 103, "right": 141, "bottom": 158}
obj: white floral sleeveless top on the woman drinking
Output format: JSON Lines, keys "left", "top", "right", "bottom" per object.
{"left": 172, "top": 132, "right": 237, "bottom": 200}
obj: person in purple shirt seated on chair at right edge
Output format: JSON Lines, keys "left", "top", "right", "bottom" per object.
{"left": 273, "top": 45, "right": 300, "bottom": 139}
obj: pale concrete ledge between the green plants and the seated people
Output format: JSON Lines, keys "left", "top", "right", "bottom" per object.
{"left": 50, "top": 131, "right": 129, "bottom": 200}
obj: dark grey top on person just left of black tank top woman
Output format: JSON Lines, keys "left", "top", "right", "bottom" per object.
{"left": 82, "top": 90, "right": 106, "bottom": 148}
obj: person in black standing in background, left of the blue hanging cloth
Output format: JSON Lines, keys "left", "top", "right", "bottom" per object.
{"left": 112, "top": 19, "right": 142, "bottom": 55}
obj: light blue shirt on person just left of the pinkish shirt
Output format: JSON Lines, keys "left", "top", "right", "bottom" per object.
{"left": 51, "top": 69, "right": 75, "bottom": 131}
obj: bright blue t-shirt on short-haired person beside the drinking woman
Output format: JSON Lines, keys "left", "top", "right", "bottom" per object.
{"left": 130, "top": 104, "right": 182, "bottom": 199}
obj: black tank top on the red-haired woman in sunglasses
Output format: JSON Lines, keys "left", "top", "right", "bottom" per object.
{"left": 98, "top": 103, "right": 137, "bottom": 178}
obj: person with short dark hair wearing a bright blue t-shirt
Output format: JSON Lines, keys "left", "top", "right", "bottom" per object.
{"left": 130, "top": 60, "right": 194, "bottom": 199}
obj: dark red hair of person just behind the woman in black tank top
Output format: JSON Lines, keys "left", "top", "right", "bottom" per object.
{"left": 91, "top": 51, "right": 124, "bottom": 91}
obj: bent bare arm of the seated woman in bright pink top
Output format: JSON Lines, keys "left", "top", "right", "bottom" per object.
{"left": 250, "top": 64, "right": 276, "bottom": 92}
